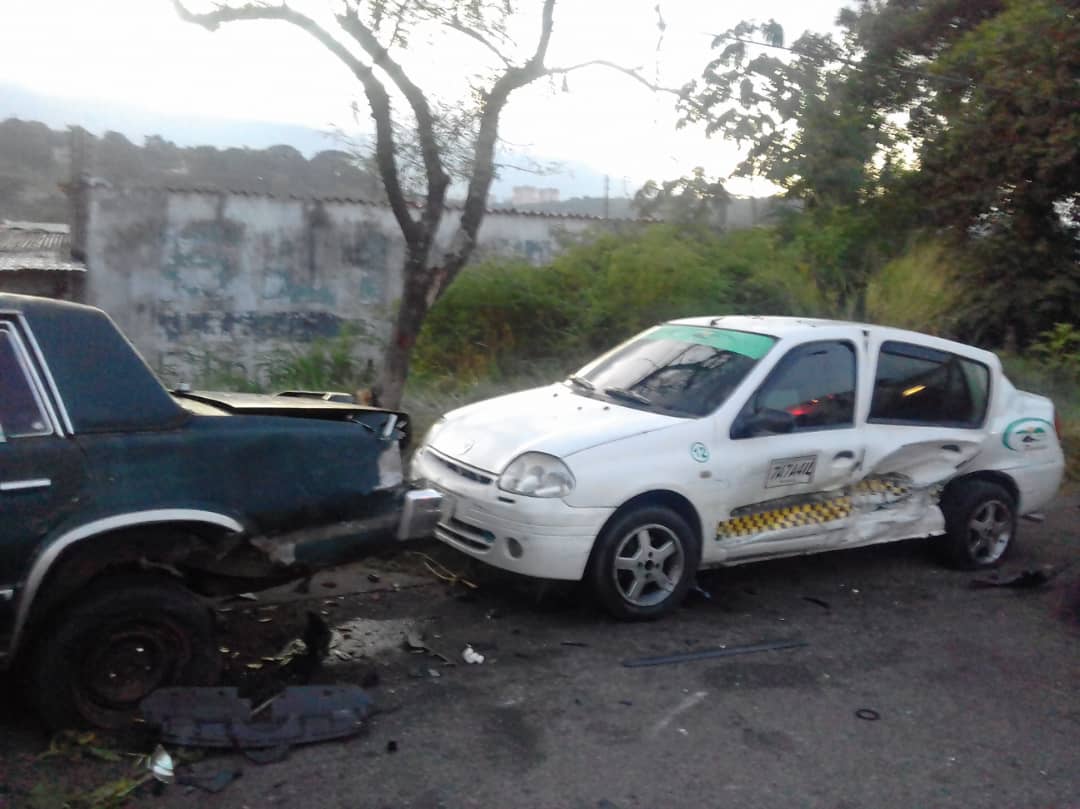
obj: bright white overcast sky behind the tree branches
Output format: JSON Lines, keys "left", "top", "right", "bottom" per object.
{"left": 0, "top": 0, "right": 842, "bottom": 193}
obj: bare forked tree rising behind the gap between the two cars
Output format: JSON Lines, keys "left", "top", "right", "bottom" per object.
{"left": 173, "top": 0, "right": 662, "bottom": 406}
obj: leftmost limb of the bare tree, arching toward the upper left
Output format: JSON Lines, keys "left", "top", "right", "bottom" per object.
{"left": 173, "top": 0, "right": 418, "bottom": 242}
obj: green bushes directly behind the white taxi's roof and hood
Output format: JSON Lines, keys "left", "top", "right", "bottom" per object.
{"left": 413, "top": 225, "right": 825, "bottom": 386}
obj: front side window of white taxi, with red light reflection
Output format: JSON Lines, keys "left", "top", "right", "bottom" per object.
{"left": 731, "top": 340, "right": 855, "bottom": 439}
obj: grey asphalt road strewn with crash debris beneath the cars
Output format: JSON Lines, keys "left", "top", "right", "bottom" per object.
{"left": 0, "top": 491, "right": 1080, "bottom": 809}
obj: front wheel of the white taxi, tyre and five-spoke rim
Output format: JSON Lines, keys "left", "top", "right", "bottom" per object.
{"left": 590, "top": 505, "right": 701, "bottom": 620}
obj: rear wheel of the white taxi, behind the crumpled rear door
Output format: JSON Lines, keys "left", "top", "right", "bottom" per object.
{"left": 941, "top": 480, "right": 1016, "bottom": 570}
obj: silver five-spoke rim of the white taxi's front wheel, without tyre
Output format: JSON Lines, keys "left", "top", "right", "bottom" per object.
{"left": 613, "top": 524, "right": 686, "bottom": 607}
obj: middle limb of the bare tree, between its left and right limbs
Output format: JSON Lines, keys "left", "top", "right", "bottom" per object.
{"left": 337, "top": 6, "right": 450, "bottom": 244}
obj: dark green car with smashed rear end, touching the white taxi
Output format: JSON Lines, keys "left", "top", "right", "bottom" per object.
{"left": 0, "top": 294, "right": 440, "bottom": 727}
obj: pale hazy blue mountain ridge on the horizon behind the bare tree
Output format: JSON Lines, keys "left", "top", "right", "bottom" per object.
{"left": 0, "top": 83, "right": 622, "bottom": 200}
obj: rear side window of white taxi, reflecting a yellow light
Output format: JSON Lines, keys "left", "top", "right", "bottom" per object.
{"left": 869, "top": 340, "right": 990, "bottom": 427}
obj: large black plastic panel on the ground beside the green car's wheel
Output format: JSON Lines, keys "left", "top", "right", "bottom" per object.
{"left": 141, "top": 686, "right": 372, "bottom": 750}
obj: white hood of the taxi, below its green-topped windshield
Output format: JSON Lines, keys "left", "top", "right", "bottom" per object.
{"left": 429, "top": 383, "right": 685, "bottom": 474}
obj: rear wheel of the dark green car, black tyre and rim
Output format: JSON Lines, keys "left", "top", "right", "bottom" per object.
{"left": 30, "top": 576, "right": 220, "bottom": 729}
